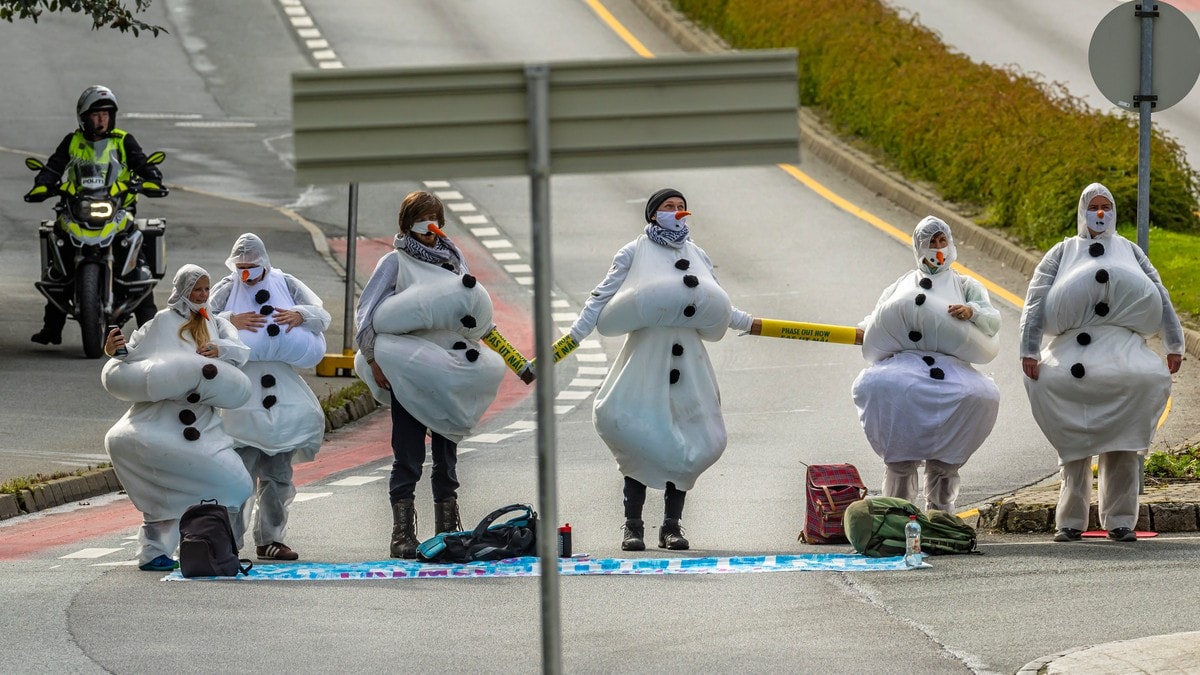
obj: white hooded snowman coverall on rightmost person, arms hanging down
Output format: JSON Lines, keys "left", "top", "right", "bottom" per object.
{"left": 1021, "top": 183, "right": 1183, "bottom": 530}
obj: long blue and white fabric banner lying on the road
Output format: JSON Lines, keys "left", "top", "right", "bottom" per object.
{"left": 164, "top": 554, "right": 930, "bottom": 581}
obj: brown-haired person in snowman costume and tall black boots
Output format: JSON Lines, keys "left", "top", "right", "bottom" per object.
{"left": 354, "top": 191, "right": 532, "bottom": 558}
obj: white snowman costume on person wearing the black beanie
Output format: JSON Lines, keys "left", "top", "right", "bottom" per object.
{"left": 570, "top": 218, "right": 752, "bottom": 491}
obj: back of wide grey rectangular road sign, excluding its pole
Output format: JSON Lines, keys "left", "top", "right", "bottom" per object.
{"left": 292, "top": 50, "right": 799, "bottom": 184}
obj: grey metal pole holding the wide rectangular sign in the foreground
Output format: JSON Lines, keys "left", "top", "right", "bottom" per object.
{"left": 526, "top": 64, "right": 563, "bottom": 675}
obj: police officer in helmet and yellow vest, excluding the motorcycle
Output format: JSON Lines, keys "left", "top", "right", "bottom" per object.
{"left": 25, "top": 84, "right": 162, "bottom": 345}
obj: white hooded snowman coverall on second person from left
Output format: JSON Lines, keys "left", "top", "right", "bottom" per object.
{"left": 209, "top": 233, "right": 331, "bottom": 546}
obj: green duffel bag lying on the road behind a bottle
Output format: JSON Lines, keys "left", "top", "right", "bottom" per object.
{"left": 842, "top": 497, "right": 982, "bottom": 557}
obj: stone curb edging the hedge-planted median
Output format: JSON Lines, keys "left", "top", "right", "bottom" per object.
{"left": 630, "top": 0, "right": 1200, "bottom": 358}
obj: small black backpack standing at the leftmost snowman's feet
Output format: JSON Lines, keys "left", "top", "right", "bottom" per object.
{"left": 179, "top": 500, "right": 254, "bottom": 577}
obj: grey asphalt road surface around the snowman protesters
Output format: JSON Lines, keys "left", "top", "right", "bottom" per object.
{"left": 0, "top": 0, "right": 1195, "bottom": 673}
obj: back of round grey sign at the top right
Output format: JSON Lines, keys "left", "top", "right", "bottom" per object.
{"left": 1087, "top": 1, "right": 1200, "bottom": 113}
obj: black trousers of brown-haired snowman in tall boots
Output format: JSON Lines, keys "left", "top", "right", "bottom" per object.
{"left": 388, "top": 394, "right": 458, "bottom": 503}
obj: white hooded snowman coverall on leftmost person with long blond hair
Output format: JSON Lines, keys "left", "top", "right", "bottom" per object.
{"left": 101, "top": 264, "right": 252, "bottom": 563}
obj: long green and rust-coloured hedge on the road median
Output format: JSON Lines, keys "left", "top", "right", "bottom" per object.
{"left": 673, "top": 0, "right": 1200, "bottom": 249}
